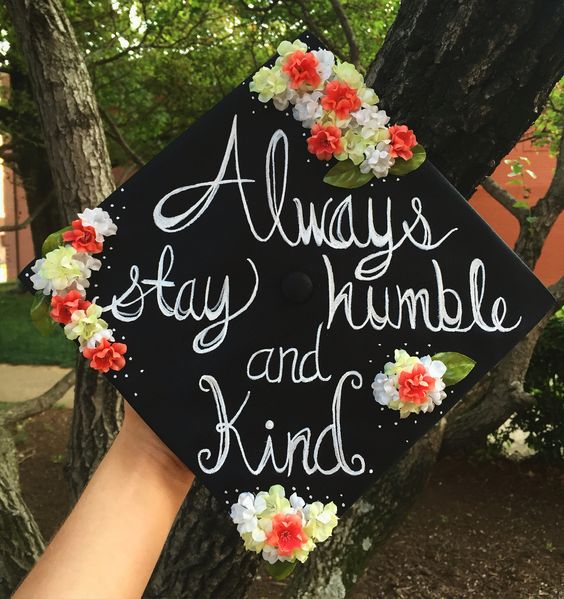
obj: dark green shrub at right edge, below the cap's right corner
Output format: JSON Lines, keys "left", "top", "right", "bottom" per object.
{"left": 493, "top": 308, "right": 564, "bottom": 462}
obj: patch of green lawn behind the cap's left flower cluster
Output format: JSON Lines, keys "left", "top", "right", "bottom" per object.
{"left": 0, "top": 283, "right": 76, "bottom": 367}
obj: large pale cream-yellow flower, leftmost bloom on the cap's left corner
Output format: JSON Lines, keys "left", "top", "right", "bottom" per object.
{"left": 30, "top": 245, "right": 90, "bottom": 295}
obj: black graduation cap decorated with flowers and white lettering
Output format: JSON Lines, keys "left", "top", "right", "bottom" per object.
{"left": 18, "top": 34, "right": 553, "bottom": 572}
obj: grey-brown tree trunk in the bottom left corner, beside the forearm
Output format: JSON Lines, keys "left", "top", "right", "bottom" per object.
{"left": 0, "top": 425, "right": 44, "bottom": 599}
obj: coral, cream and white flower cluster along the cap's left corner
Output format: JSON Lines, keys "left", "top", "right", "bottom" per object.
{"left": 31, "top": 208, "right": 127, "bottom": 372}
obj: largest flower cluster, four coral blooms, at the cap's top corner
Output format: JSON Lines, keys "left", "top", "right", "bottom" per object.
{"left": 249, "top": 40, "right": 417, "bottom": 182}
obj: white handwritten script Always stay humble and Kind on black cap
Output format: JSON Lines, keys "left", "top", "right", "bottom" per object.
{"left": 108, "top": 116, "right": 521, "bottom": 476}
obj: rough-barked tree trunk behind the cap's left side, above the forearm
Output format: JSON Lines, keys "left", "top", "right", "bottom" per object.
{"left": 7, "top": 0, "right": 120, "bottom": 496}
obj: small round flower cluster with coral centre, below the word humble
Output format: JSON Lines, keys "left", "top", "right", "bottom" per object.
{"left": 372, "top": 349, "right": 447, "bottom": 418}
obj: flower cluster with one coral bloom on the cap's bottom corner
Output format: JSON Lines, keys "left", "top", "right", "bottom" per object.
{"left": 231, "top": 485, "right": 338, "bottom": 564}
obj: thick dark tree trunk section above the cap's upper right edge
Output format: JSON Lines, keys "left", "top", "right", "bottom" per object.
{"left": 367, "top": 0, "right": 564, "bottom": 197}
